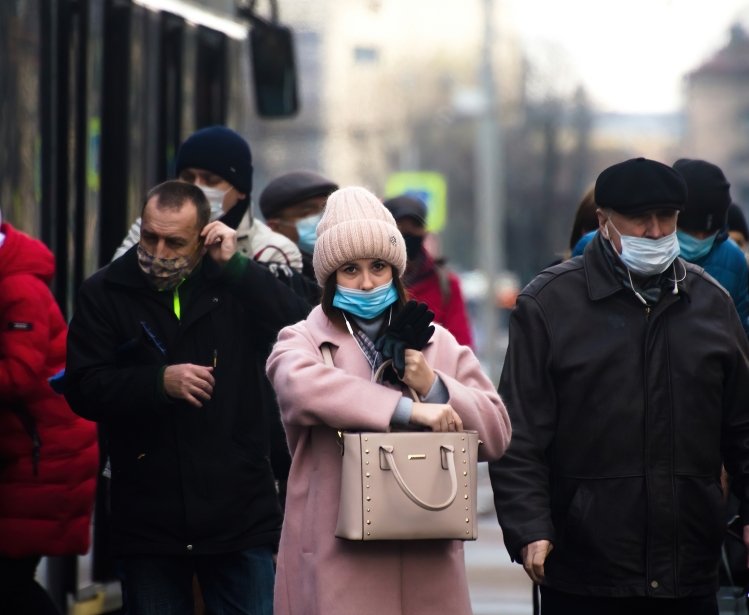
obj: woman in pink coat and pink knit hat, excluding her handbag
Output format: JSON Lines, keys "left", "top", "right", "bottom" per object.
{"left": 267, "top": 188, "right": 510, "bottom": 615}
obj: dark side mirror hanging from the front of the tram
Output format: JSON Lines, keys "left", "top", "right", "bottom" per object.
{"left": 250, "top": 18, "right": 299, "bottom": 118}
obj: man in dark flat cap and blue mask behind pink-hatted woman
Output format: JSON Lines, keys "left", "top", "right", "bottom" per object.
{"left": 260, "top": 171, "right": 338, "bottom": 292}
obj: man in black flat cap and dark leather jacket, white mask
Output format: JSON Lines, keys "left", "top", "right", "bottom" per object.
{"left": 490, "top": 158, "right": 749, "bottom": 615}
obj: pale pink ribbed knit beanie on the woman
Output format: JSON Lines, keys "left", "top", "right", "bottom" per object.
{"left": 312, "top": 186, "right": 406, "bottom": 286}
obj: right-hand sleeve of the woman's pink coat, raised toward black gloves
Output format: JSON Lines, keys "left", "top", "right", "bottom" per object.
{"left": 435, "top": 332, "right": 512, "bottom": 461}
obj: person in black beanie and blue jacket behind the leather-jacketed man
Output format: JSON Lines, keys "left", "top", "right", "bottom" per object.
{"left": 673, "top": 158, "right": 749, "bottom": 334}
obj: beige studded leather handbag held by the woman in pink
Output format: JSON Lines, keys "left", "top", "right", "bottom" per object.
{"left": 321, "top": 345, "right": 479, "bottom": 540}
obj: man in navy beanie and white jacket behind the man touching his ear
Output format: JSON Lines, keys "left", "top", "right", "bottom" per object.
{"left": 113, "top": 126, "right": 302, "bottom": 271}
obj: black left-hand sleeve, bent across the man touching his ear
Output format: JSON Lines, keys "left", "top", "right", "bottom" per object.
{"left": 65, "top": 280, "right": 164, "bottom": 421}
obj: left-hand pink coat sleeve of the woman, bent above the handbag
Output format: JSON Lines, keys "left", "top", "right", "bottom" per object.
{"left": 267, "top": 323, "right": 402, "bottom": 431}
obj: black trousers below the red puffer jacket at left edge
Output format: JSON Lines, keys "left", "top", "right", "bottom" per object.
{"left": 0, "top": 557, "right": 60, "bottom": 615}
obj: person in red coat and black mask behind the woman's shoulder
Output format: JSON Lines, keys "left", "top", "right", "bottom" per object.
{"left": 384, "top": 194, "right": 473, "bottom": 347}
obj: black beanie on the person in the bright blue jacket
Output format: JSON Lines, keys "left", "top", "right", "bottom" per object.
{"left": 674, "top": 158, "right": 731, "bottom": 231}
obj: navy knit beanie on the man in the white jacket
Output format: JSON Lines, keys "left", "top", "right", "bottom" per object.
{"left": 175, "top": 126, "right": 252, "bottom": 197}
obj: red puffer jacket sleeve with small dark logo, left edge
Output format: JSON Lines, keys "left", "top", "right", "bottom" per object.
{"left": 0, "top": 275, "right": 54, "bottom": 402}
